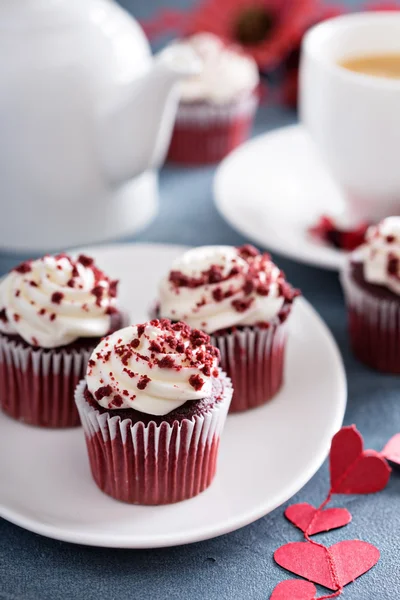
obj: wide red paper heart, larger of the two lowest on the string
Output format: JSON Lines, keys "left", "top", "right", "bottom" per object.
{"left": 274, "top": 540, "right": 379, "bottom": 590}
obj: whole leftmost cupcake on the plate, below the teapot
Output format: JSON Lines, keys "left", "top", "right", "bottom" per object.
{"left": 0, "top": 254, "right": 122, "bottom": 427}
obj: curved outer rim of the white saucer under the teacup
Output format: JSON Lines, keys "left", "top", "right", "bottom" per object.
{"left": 212, "top": 123, "right": 346, "bottom": 271}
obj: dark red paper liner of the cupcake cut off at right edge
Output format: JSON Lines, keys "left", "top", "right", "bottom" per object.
{"left": 341, "top": 266, "right": 400, "bottom": 375}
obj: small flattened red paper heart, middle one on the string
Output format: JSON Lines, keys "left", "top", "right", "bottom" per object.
{"left": 285, "top": 502, "right": 351, "bottom": 535}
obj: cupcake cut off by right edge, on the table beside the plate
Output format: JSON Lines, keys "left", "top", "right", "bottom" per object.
{"left": 341, "top": 217, "right": 400, "bottom": 374}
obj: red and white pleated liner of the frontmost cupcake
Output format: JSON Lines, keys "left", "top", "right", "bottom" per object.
{"left": 75, "top": 374, "right": 232, "bottom": 505}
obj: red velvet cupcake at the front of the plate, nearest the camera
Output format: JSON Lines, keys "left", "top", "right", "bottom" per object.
{"left": 75, "top": 319, "right": 232, "bottom": 504}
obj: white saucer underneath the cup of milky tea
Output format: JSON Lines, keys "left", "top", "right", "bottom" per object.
{"left": 214, "top": 125, "right": 344, "bottom": 269}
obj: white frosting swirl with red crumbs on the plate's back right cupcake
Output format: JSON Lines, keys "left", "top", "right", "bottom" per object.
{"left": 159, "top": 246, "right": 293, "bottom": 333}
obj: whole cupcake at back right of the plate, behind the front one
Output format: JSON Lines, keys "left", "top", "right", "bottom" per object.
{"left": 157, "top": 245, "right": 298, "bottom": 412}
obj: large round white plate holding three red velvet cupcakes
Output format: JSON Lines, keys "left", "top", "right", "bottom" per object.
{"left": 0, "top": 244, "right": 346, "bottom": 548}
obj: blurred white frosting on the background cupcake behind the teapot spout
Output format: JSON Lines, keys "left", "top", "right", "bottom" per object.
{"left": 175, "top": 33, "right": 259, "bottom": 104}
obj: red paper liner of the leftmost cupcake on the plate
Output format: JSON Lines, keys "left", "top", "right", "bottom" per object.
{"left": 0, "top": 335, "right": 91, "bottom": 428}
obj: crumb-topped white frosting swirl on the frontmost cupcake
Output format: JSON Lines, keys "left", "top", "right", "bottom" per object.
{"left": 86, "top": 320, "right": 218, "bottom": 415}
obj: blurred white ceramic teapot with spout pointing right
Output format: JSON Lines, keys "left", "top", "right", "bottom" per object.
{"left": 0, "top": 0, "right": 199, "bottom": 251}
